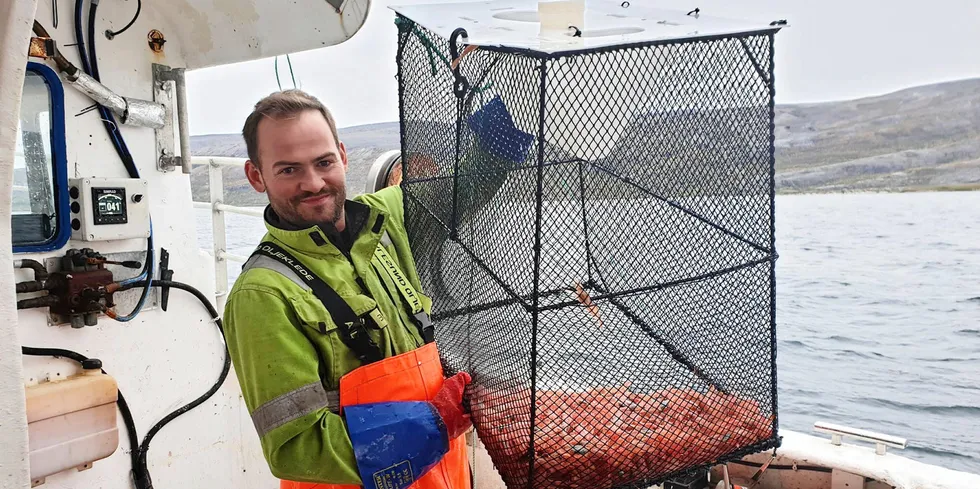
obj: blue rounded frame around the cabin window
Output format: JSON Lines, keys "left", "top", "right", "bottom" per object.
{"left": 10, "top": 61, "right": 71, "bottom": 253}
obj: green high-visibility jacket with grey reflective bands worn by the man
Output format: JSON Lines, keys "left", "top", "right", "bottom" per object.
{"left": 224, "top": 186, "right": 431, "bottom": 484}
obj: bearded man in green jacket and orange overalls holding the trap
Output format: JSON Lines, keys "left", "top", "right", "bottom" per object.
{"left": 224, "top": 90, "right": 471, "bottom": 489}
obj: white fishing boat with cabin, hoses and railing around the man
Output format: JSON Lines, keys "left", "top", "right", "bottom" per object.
{"left": 0, "top": 0, "right": 980, "bottom": 489}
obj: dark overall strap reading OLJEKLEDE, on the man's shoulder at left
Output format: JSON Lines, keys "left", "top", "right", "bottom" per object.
{"left": 252, "top": 241, "right": 384, "bottom": 364}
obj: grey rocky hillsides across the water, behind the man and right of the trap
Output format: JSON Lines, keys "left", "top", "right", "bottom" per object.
{"left": 191, "top": 79, "right": 980, "bottom": 205}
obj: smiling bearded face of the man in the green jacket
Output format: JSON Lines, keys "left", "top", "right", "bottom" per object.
{"left": 245, "top": 110, "right": 347, "bottom": 231}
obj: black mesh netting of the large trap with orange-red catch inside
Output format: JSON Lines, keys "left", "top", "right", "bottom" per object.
{"left": 398, "top": 17, "right": 778, "bottom": 489}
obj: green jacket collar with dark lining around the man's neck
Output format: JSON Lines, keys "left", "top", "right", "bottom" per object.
{"left": 264, "top": 200, "right": 387, "bottom": 255}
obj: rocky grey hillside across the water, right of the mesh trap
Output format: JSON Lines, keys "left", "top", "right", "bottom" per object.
{"left": 776, "top": 79, "right": 980, "bottom": 192}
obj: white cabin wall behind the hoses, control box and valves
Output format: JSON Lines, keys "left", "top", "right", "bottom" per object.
{"left": 15, "top": 0, "right": 278, "bottom": 489}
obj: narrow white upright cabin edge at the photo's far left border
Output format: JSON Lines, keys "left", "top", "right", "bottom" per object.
{"left": 0, "top": 0, "right": 36, "bottom": 489}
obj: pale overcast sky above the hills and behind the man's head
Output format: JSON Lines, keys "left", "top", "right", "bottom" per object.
{"left": 188, "top": 0, "right": 980, "bottom": 134}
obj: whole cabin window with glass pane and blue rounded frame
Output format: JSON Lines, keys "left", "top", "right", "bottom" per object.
{"left": 11, "top": 63, "right": 70, "bottom": 252}
